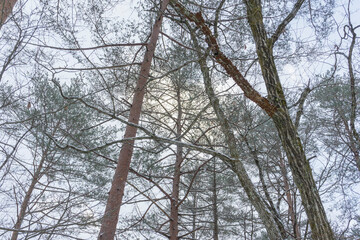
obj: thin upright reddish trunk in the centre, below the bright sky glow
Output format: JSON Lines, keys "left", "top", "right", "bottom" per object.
{"left": 170, "top": 86, "right": 183, "bottom": 240}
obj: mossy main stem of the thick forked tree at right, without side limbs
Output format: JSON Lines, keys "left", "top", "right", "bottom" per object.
{"left": 244, "top": 0, "right": 334, "bottom": 240}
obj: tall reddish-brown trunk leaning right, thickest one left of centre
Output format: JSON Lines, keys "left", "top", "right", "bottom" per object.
{"left": 99, "top": 0, "right": 169, "bottom": 240}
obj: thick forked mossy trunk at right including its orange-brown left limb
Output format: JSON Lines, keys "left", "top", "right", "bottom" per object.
{"left": 171, "top": 0, "right": 334, "bottom": 240}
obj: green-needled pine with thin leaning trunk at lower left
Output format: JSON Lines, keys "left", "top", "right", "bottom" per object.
{"left": 1, "top": 75, "right": 115, "bottom": 239}
